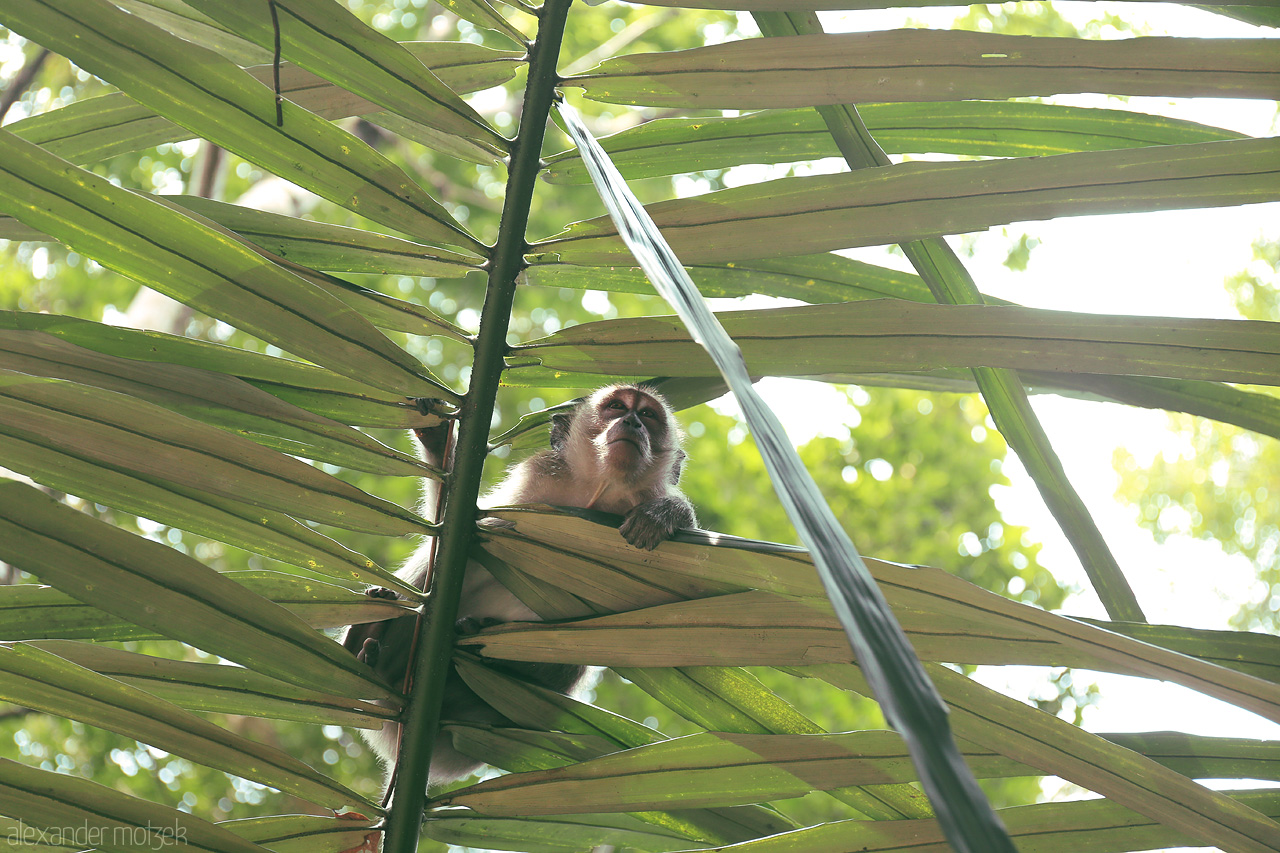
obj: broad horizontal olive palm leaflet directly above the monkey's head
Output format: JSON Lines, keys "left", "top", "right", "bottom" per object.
{"left": 508, "top": 300, "right": 1280, "bottom": 384}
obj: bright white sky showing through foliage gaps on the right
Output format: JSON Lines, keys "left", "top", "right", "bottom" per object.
{"left": 706, "top": 1, "right": 1280, "bottom": 824}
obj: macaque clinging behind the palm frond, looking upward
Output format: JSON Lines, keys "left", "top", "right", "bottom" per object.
{"left": 346, "top": 386, "right": 698, "bottom": 788}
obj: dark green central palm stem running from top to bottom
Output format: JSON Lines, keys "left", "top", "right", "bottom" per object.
{"left": 383, "top": 0, "right": 572, "bottom": 853}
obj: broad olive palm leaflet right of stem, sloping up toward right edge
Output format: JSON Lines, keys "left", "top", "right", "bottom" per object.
{"left": 536, "top": 140, "right": 1280, "bottom": 265}
